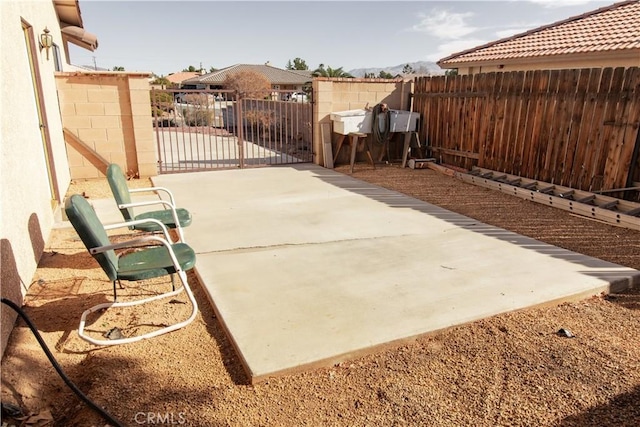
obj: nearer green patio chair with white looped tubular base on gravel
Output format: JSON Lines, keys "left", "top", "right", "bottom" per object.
{"left": 65, "top": 194, "right": 198, "bottom": 345}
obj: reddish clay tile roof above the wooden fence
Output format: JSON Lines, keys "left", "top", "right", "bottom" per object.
{"left": 438, "top": 0, "right": 640, "bottom": 66}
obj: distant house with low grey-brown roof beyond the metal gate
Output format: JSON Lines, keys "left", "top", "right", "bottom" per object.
{"left": 182, "top": 62, "right": 312, "bottom": 91}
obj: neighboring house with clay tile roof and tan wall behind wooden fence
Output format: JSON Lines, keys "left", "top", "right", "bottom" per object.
{"left": 438, "top": 0, "right": 640, "bottom": 74}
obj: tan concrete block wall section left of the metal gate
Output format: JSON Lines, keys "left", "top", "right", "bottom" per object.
{"left": 56, "top": 72, "right": 157, "bottom": 179}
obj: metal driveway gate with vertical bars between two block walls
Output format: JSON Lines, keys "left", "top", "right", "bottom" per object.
{"left": 151, "top": 89, "right": 313, "bottom": 174}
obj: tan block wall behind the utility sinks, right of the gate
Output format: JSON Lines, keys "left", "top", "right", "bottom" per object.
{"left": 313, "top": 77, "right": 413, "bottom": 166}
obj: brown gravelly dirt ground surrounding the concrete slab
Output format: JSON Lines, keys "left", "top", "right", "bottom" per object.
{"left": 2, "top": 164, "right": 640, "bottom": 426}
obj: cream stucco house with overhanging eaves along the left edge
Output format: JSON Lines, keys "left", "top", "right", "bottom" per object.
{"left": 0, "top": 0, "right": 98, "bottom": 354}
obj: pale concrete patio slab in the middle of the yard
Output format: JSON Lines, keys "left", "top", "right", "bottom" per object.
{"left": 148, "top": 165, "right": 640, "bottom": 381}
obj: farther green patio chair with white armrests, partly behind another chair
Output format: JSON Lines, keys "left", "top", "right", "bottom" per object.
{"left": 107, "top": 163, "right": 191, "bottom": 242}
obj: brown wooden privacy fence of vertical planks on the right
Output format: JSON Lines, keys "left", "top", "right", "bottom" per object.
{"left": 413, "top": 67, "right": 640, "bottom": 196}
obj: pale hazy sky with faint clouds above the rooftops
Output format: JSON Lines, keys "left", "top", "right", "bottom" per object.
{"left": 70, "top": 0, "right": 614, "bottom": 76}
